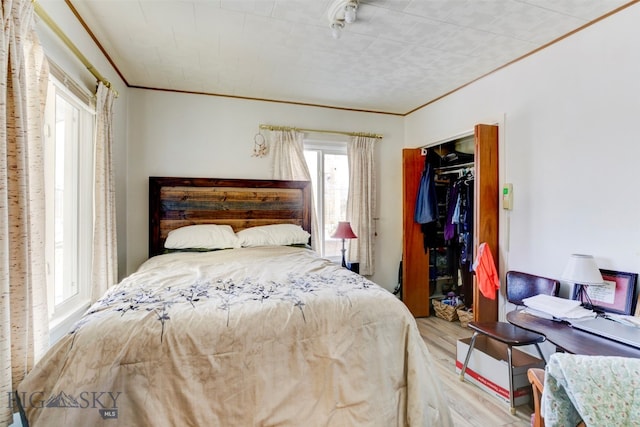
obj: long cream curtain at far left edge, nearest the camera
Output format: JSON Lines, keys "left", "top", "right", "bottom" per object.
{"left": 0, "top": 0, "right": 49, "bottom": 425}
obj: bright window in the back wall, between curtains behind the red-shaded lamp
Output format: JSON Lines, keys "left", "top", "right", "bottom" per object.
{"left": 304, "top": 140, "right": 349, "bottom": 261}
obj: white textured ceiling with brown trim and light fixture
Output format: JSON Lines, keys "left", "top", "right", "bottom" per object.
{"left": 66, "top": 0, "right": 628, "bottom": 114}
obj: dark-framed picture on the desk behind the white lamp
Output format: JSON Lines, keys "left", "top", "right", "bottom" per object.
{"left": 572, "top": 269, "right": 640, "bottom": 315}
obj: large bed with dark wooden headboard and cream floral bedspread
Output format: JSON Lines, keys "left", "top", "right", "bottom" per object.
{"left": 16, "top": 177, "right": 452, "bottom": 427}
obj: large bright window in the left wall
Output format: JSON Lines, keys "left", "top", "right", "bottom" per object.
{"left": 44, "top": 75, "right": 94, "bottom": 329}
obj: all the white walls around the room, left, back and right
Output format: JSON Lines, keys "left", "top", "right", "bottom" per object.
{"left": 37, "top": 0, "right": 640, "bottom": 310}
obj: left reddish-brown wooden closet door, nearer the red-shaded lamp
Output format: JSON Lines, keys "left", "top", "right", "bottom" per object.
{"left": 402, "top": 148, "right": 429, "bottom": 317}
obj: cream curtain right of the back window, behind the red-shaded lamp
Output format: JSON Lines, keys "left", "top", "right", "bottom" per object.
{"left": 347, "top": 136, "right": 377, "bottom": 276}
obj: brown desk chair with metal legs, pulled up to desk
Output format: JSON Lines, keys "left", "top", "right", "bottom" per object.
{"left": 460, "top": 271, "right": 560, "bottom": 414}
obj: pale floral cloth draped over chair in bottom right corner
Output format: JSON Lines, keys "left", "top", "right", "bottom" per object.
{"left": 541, "top": 353, "right": 640, "bottom": 427}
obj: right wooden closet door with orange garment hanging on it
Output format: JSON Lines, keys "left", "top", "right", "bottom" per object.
{"left": 473, "top": 125, "right": 500, "bottom": 322}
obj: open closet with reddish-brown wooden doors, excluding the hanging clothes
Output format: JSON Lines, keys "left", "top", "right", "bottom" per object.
{"left": 402, "top": 125, "right": 500, "bottom": 321}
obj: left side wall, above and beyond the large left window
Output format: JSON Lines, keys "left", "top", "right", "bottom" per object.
{"left": 36, "top": 0, "right": 128, "bottom": 277}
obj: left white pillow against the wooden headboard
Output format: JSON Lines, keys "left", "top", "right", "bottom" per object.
{"left": 164, "top": 224, "right": 240, "bottom": 249}
